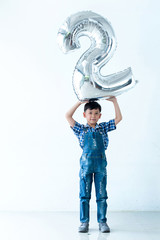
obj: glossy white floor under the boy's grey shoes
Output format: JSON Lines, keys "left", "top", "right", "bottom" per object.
{"left": 0, "top": 212, "right": 160, "bottom": 240}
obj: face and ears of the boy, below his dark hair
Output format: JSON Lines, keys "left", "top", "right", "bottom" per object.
{"left": 83, "top": 109, "right": 101, "bottom": 127}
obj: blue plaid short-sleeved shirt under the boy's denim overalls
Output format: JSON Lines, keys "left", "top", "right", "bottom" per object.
{"left": 71, "top": 119, "right": 116, "bottom": 150}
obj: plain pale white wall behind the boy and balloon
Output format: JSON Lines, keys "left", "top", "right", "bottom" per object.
{"left": 0, "top": 0, "right": 160, "bottom": 211}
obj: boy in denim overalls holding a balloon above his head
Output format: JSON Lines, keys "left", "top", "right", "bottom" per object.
{"left": 66, "top": 97, "right": 122, "bottom": 232}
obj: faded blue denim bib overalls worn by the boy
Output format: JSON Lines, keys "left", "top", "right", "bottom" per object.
{"left": 80, "top": 127, "right": 108, "bottom": 223}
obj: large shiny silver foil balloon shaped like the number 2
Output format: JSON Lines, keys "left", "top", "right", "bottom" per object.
{"left": 57, "top": 11, "right": 137, "bottom": 101}
